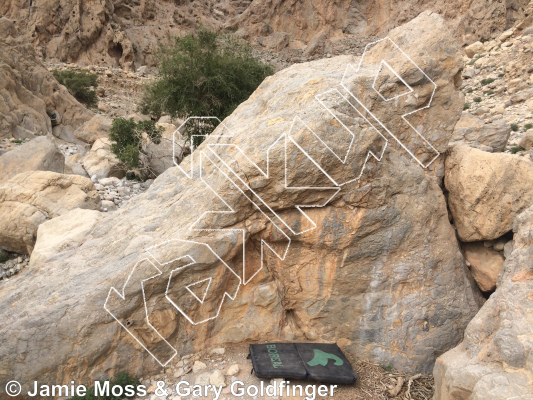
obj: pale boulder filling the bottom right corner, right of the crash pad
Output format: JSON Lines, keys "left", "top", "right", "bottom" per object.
{"left": 433, "top": 208, "right": 533, "bottom": 400}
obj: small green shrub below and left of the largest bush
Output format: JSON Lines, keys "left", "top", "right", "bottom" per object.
{"left": 109, "top": 118, "right": 164, "bottom": 169}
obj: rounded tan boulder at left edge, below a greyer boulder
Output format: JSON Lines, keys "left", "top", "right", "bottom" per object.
{"left": 0, "top": 171, "right": 101, "bottom": 254}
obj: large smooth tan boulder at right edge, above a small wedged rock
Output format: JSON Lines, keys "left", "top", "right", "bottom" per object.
{"left": 444, "top": 145, "right": 533, "bottom": 242}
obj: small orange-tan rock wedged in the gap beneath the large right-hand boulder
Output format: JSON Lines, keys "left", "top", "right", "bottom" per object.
{"left": 463, "top": 242, "right": 505, "bottom": 292}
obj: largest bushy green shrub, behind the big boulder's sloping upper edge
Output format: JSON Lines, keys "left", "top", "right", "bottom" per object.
{"left": 139, "top": 29, "right": 274, "bottom": 144}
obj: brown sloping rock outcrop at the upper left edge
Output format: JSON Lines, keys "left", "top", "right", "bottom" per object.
{"left": 0, "top": 17, "right": 92, "bottom": 138}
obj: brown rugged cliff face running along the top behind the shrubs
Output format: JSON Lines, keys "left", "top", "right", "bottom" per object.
{"left": 0, "top": 0, "right": 529, "bottom": 69}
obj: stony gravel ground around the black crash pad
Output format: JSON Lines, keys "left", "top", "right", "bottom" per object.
{"left": 137, "top": 344, "right": 433, "bottom": 400}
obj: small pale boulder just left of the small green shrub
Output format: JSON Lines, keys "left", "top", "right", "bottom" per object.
{"left": 81, "top": 138, "right": 126, "bottom": 179}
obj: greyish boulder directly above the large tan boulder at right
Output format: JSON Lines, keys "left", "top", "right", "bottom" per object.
{"left": 450, "top": 112, "right": 511, "bottom": 153}
